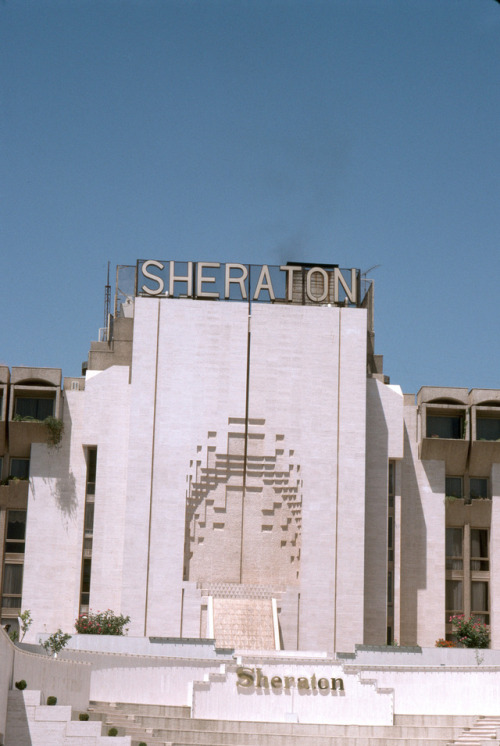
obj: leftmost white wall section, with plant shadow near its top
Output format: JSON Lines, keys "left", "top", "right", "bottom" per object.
{"left": 22, "top": 391, "right": 86, "bottom": 642}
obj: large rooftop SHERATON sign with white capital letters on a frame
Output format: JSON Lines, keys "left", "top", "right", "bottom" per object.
{"left": 136, "top": 259, "right": 360, "bottom": 306}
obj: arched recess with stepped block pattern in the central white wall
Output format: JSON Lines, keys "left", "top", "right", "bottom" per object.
{"left": 184, "top": 417, "right": 302, "bottom": 588}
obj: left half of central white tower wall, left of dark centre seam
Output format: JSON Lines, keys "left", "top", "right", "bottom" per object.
{"left": 124, "top": 299, "right": 248, "bottom": 635}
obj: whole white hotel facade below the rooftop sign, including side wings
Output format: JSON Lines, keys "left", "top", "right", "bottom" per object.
{"left": 0, "top": 262, "right": 500, "bottom": 653}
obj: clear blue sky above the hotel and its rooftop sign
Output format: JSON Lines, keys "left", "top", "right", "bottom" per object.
{"left": 0, "top": 0, "right": 500, "bottom": 393}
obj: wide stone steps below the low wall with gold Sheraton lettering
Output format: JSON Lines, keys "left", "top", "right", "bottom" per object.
{"left": 89, "top": 702, "right": 478, "bottom": 746}
